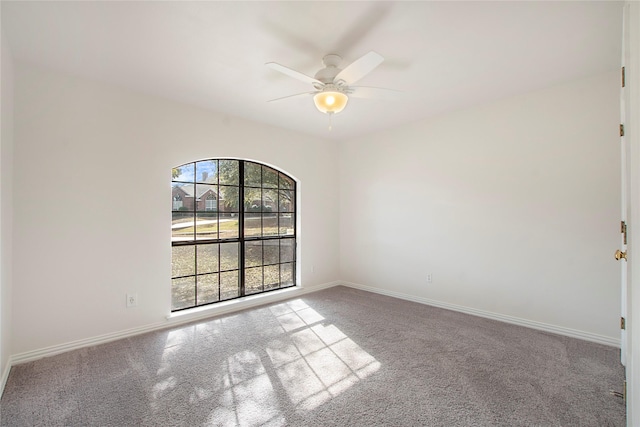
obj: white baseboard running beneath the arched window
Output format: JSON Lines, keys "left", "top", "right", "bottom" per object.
{"left": 7, "top": 282, "right": 341, "bottom": 366}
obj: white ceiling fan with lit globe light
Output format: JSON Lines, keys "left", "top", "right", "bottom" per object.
{"left": 265, "top": 51, "right": 396, "bottom": 115}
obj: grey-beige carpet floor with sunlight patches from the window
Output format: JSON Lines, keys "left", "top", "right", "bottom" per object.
{"left": 0, "top": 287, "right": 625, "bottom": 427}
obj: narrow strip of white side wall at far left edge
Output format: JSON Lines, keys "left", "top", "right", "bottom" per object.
{"left": 0, "top": 31, "right": 13, "bottom": 388}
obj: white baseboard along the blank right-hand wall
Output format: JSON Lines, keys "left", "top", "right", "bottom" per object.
{"left": 341, "top": 281, "right": 620, "bottom": 348}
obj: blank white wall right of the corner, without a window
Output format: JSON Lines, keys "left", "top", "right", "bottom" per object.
{"left": 340, "top": 72, "right": 620, "bottom": 342}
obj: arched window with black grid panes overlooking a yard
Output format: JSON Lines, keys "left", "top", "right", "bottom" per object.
{"left": 171, "top": 159, "right": 296, "bottom": 311}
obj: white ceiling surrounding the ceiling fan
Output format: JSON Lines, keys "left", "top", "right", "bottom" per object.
{"left": 1, "top": 1, "right": 622, "bottom": 140}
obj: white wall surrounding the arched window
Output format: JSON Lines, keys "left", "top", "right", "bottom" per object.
{"left": 13, "top": 63, "right": 338, "bottom": 354}
